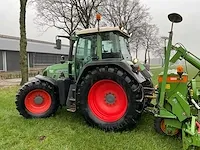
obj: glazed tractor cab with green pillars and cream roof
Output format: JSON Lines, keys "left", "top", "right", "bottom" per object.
{"left": 75, "top": 27, "right": 131, "bottom": 74}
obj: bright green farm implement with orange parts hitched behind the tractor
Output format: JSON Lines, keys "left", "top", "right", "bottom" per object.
{"left": 154, "top": 13, "right": 200, "bottom": 150}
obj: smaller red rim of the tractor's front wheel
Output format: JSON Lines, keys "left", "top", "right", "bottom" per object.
{"left": 25, "top": 89, "right": 51, "bottom": 114}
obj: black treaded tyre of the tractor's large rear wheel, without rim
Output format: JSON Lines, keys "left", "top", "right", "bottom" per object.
{"left": 77, "top": 67, "right": 144, "bottom": 131}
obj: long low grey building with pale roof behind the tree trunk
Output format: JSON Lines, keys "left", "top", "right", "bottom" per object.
{"left": 0, "top": 35, "right": 69, "bottom": 71}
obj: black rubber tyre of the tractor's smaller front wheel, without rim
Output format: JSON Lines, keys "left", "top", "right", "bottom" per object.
{"left": 15, "top": 80, "right": 59, "bottom": 118}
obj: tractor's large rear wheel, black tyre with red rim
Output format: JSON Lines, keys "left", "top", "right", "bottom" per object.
{"left": 78, "top": 67, "right": 144, "bottom": 131}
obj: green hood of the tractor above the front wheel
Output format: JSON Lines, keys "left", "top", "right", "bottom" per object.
{"left": 42, "top": 61, "right": 74, "bottom": 79}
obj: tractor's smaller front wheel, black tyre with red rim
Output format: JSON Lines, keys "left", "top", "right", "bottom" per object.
{"left": 15, "top": 81, "right": 58, "bottom": 118}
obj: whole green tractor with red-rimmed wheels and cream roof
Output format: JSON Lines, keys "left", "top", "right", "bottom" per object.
{"left": 16, "top": 24, "right": 154, "bottom": 131}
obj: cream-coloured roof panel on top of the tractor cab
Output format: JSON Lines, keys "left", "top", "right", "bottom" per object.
{"left": 76, "top": 27, "right": 130, "bottom": 37}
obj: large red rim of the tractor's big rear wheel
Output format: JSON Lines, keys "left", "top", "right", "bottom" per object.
{"left": 88, "top": 80, "right": 128, "bottom": 122}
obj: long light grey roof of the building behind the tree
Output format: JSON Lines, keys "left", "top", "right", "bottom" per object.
{"left": 0, "top": 35, "right": 69, "bottom": 55}
